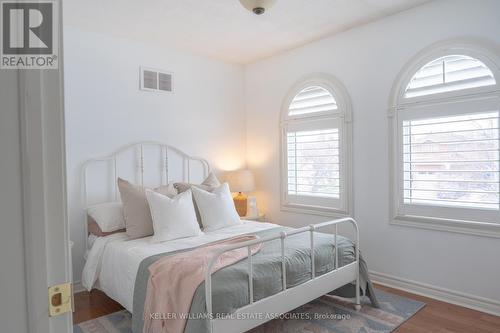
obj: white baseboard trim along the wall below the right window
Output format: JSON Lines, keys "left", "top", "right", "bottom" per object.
{"left": 370, "top": 271, "right": 500, "bottom": 316}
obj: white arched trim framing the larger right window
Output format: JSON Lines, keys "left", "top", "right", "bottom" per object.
{"left": 388, "top": 39, "right": 500, "bottom": 238}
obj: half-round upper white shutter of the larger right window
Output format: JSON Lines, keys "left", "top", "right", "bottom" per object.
{"left": 404, "top": 55, "right": 496, "bottom": 98}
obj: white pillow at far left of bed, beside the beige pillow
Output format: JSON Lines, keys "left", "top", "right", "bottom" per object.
{"left": 87, "top": 202, "right": 125, "bottom": 232}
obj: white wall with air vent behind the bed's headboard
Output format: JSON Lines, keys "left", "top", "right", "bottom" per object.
{"left": 64, "top": 26, "right": 245, "bottom": 281}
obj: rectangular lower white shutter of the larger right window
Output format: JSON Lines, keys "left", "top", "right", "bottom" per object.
{"left": 402, "top": 112, "right": 500, "bottom": 210}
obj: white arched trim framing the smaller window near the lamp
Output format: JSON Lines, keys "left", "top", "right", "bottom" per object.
{"left": 279, "top": 73, "right": 353, "bottom": 217}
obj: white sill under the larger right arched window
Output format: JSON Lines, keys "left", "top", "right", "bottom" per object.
{"left": 390, "top": 215, "right": 500, "bottom": 238}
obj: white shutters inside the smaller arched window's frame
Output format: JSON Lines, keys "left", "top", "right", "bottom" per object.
{"left": 282, "top": 84, "right": 345, "bottom": 212}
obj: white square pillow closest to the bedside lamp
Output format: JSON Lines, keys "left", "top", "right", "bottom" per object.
{"left": 191, "top": 183, "right": 242, "bottom": 231}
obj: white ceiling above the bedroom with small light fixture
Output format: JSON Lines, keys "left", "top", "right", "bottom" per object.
{"left": 64, "top": 0, "right": 429, "bottom": 64}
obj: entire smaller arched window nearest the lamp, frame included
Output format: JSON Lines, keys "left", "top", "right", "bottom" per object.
{"left": 281, "top": 74, "right": 351, "bottom": 215}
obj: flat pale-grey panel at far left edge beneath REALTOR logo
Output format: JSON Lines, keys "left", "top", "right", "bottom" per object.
{"left": 0, "top": 59, "right": 27, "bottom": 332}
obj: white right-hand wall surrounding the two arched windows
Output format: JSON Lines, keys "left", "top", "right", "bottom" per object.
{"left": 245, "top": 0, "right": 500, "bottom": 301}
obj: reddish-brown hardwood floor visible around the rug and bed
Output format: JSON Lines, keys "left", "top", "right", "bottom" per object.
{"left": 73, "top": 285, "right": 500, "bottom": 333}
